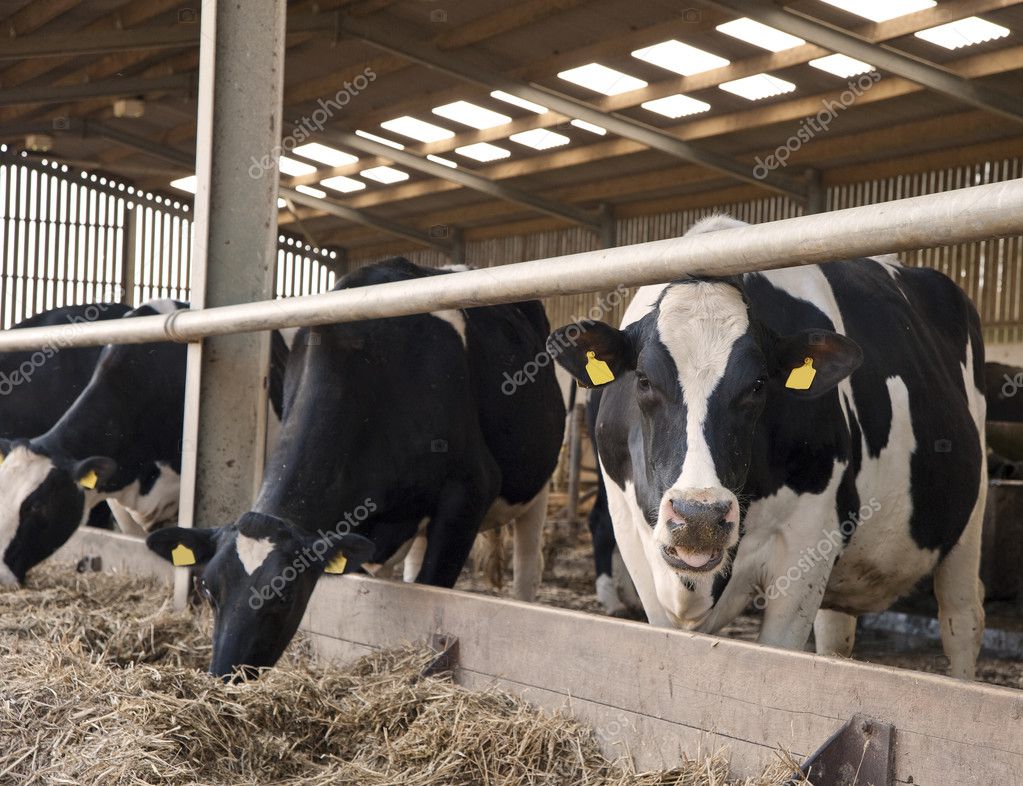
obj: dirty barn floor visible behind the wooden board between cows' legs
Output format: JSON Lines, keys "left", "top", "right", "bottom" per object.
{"left": 455, "top": 505, "right": 1023, "bottom": 688}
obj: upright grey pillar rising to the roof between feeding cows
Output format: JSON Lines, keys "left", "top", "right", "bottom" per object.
{"left": 176, "top": 0, "right": 285, "bottom": 603}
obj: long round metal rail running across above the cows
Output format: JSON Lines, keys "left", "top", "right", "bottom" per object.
{"left": 0, "top": 179, "right": 1023, "bottom": 352}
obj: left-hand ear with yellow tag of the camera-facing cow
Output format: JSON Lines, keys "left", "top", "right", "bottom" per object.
{"left": 547, "top": 319, "right": 636, "bottom": 388}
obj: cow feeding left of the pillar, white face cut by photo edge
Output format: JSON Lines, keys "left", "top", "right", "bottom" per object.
{"left": 0, "top": 300, "right": 286, "bottom": 585}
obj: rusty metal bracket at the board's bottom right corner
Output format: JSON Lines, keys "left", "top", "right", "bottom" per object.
{"left": 785, "top": 715, "right": 895, "bottom": 786}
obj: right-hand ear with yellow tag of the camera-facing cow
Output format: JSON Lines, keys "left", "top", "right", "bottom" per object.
{"left": 775, "top": 330, "right": 863, "bottom": 398}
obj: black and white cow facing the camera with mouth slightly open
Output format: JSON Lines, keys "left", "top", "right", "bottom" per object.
{"left": 548, "top": 217, "right": 986, "bottom": 678}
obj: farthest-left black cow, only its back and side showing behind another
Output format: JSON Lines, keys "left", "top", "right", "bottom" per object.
{"left": 0, "top": 303, "right": 130, "bottom": 439}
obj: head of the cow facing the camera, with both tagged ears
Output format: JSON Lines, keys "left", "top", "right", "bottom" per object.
{"left": 547, "top": 279, "right": 862, "bottom": 578}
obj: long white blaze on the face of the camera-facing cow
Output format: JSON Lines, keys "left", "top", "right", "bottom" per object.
{"left": 655, "top": 281, "right": 750, "bottom": 540}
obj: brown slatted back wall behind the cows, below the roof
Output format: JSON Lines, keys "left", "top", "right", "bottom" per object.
{"left": 352, "top": 159, "right": 1023, "bottom": 343}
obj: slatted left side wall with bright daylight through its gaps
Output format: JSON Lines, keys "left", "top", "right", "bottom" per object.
{"left": 0, "top": 150, "right": 336, "bottom": 329}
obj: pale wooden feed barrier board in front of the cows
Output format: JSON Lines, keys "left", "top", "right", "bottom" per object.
{"left": 54, "top": 529, "right": 1023, "bottom": 786}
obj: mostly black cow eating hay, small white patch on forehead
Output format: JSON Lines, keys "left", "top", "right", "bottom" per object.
{"left": 147, "top": 258, "right": 565, "bottom": 675}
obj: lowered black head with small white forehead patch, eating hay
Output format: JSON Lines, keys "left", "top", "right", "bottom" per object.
{"left": 146, "top": 513, "right": 373, "bottom": 678}
